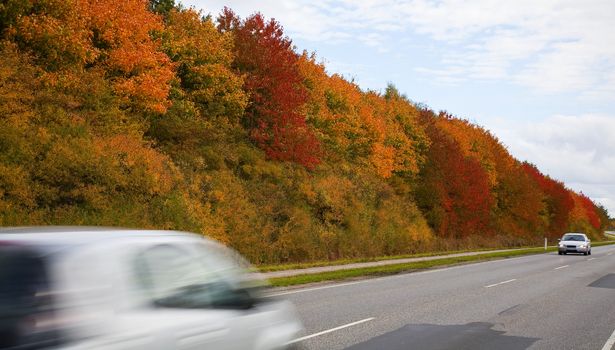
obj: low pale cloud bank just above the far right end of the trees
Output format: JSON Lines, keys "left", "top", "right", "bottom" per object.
{"left": 492, "top": 114, "right": 615, "bottom": 216}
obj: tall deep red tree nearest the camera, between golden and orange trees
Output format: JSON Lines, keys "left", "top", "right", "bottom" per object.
{"left": 218, "top": 8, "right": 320, "bottom": 169}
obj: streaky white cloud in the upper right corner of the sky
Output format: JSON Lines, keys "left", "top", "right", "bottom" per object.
{"left": 404, "top": 0, "right": 615, "bottom": 95}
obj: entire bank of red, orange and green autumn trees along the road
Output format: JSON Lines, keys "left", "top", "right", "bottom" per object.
{"left": 0, "top": 0, "right": 609, "bottom": 263}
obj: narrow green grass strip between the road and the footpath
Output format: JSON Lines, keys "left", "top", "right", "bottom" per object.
{"left": 269, "top": 241, "right": 615, "bottom": 287}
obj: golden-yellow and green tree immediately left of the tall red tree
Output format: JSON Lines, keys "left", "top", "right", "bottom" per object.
{"left": 148, "top": 9, "right": 247, "bottom": 162}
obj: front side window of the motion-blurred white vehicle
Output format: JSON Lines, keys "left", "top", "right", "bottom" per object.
{"left": 135, "top": 244, "right": 253, "bottom": 308}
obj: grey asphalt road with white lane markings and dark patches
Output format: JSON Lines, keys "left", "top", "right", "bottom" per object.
{"left": 276, "top": 246, "right": 615, "bottom": 350}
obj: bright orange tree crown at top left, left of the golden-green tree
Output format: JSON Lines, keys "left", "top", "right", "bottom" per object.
{"left": 83, "top": 0, "right": 174, "bottom": 112}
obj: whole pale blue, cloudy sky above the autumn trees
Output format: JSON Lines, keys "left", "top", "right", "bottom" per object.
{"left": 181, "top": 0, "right": 615, "bottom": 217}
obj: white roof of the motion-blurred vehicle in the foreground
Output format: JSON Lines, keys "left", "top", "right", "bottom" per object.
{"left": 0, "top": 226, "right": 203, "bottom": 247}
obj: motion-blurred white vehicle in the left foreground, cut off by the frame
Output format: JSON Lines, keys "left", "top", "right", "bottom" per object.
{"left": 0, "top": 227, "right": 302, "bottom": 350}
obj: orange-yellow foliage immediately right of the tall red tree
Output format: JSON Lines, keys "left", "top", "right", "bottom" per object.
{"left": 299, "top": 53, "right": 429, "bottom": 178}
